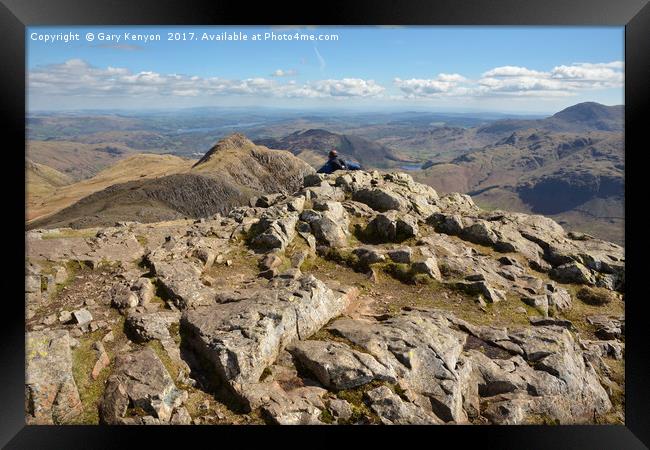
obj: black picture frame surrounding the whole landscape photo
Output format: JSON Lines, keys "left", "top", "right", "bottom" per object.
{"left": 0, "top": 0, "right": 650, "bottom": 449}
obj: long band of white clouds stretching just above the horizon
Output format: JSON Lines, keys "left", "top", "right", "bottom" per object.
{"left": 28, "top": 58, "right": 624, "bottom": 100}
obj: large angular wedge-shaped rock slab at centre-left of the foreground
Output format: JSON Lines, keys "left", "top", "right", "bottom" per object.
{"left": 181, "top": 275, "right": 352, "bottom": 406}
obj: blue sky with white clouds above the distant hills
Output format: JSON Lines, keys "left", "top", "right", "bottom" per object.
{"left": 26, "top": 26, "right": 624, "bottom": 113}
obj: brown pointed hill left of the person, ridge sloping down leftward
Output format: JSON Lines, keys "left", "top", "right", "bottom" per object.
{"left": 28, "top": 134, "right": 314, "bottom": 228}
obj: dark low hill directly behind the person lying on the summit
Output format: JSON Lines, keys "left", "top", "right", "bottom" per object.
{"left": 255, "top": 129, "right": 412, "bottom": 168}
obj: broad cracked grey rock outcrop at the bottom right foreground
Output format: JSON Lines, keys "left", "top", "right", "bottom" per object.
{"left": 329, "top": 310, "right": 611, "bottom": 424}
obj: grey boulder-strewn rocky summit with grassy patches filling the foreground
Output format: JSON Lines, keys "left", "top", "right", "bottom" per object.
{"left": 25, "top": 171, "right": 625, "bottom": 425}
